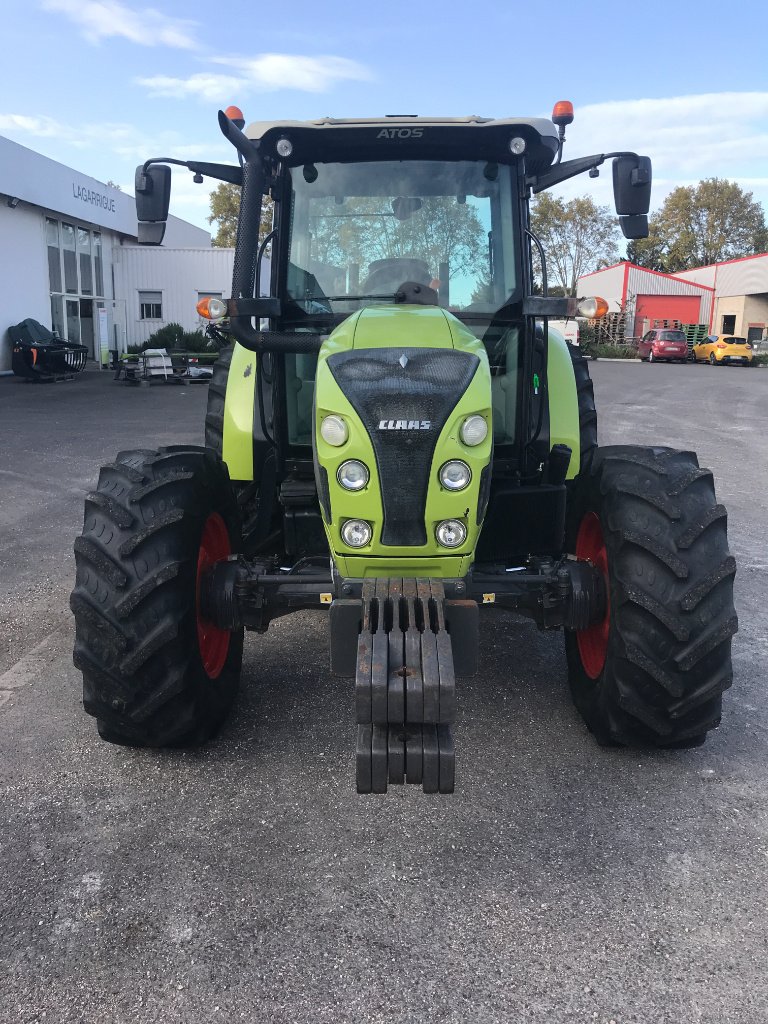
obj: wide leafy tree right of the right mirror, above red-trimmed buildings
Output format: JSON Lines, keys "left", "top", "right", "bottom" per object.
{"left": 627, "top": 178, "right": 768, "bottom": 273}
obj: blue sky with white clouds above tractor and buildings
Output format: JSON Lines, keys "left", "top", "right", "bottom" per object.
{"left": 0, "top": 0, "right": 768, "bottom": 234}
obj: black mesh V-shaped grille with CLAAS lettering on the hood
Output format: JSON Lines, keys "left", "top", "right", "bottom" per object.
{"left": 328, "top": 348, "right": 480, "bottom": 547}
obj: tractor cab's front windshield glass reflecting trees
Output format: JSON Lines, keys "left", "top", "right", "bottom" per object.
{"left": 286, "top": 161, "right": 517, "bottom": 316}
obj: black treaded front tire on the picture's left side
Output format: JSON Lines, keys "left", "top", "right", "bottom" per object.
{"left": 70, "top": 445, "right": 243, "bottom": 746}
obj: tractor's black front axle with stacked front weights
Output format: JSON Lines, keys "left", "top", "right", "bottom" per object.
{"left": 201, "top": 556, "right": 606, "bottom": 793}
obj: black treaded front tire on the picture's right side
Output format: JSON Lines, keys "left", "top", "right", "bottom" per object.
{"left": 565, "top": 445, "right": 738, "bottom": 746}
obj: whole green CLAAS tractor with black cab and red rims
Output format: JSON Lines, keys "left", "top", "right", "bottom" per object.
{"left": 72, "top": 102, "right": 737, "bottom": 793}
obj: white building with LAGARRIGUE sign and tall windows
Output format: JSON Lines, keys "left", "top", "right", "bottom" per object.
{"left": 0, "top": 137, "right": 232, "bottom": 373}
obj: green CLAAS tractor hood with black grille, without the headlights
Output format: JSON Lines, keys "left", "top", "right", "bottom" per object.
{"left": 314, "top": 305, "right": 492, "bottom": 578}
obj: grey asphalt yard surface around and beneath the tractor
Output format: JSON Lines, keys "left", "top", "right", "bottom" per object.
{"left": 0, "top": 361, "right": 768, "bottom": 1024}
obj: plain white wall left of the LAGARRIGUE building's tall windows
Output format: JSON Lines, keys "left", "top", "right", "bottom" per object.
{"left": 0, "top": 196, "right": 50, "bottom": 372}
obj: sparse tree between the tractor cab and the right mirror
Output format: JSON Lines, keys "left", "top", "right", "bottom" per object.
{"left": 530, "top": 195, "right": 618, "bottom": 295}
